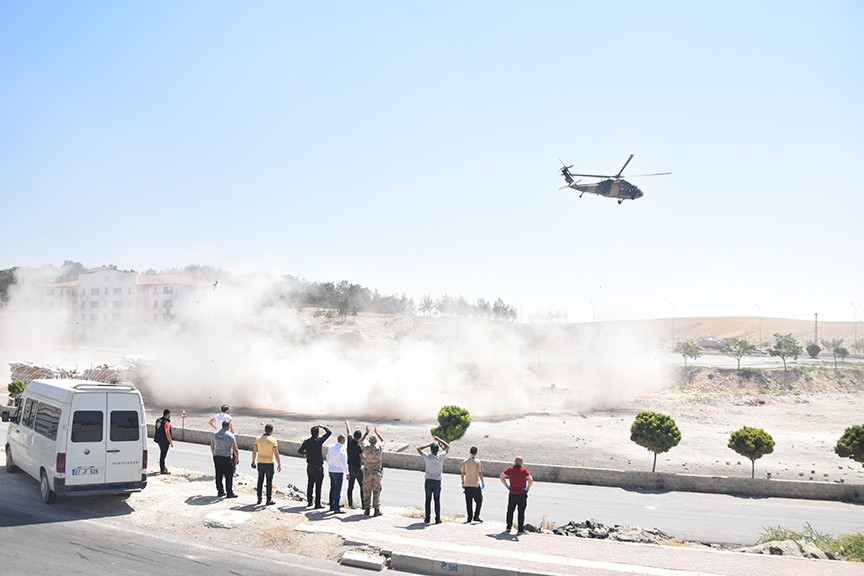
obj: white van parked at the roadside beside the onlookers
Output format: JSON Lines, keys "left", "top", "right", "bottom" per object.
{"left": 3, "top": 380, "right": 147, "bottom": 504}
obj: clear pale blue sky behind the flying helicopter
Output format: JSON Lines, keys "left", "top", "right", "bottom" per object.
{"left": 0, "top": 1, "right": 864, "bottom": 321}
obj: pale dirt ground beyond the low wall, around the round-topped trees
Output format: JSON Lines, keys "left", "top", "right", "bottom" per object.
{"left": 155, "top": 368, "right": 864, "bottom": 483}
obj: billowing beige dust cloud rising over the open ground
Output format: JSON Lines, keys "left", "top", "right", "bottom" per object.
{"left": 0, "top": 271, "right": 669, "bottom": 419}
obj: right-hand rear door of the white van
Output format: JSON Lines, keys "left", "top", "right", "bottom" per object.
{"left": 105, "top": 392, "right": 146, "bottom": 483}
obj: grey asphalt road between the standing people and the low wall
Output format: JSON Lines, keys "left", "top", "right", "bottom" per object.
{"left": 157, "top": 442, "right": 864, "bottom": 544}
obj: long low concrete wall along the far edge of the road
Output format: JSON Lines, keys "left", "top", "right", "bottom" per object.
{"left": 147, "top": 424, "right": 864, "bottom": 503}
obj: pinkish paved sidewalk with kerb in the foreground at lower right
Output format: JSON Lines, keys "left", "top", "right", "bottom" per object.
{"left": 294, "top": 506, "right": 864, "bottom": 576}
